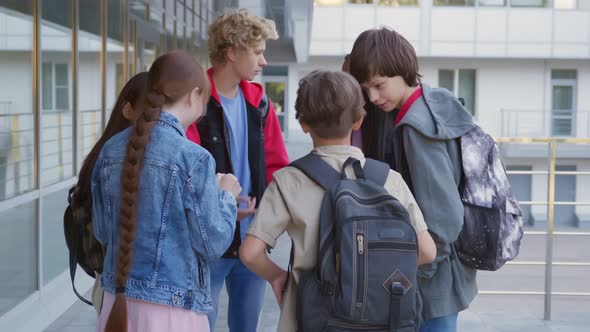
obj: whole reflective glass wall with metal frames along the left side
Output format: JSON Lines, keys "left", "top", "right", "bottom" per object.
{"left": 0, "top": 0, "right": 213, "bottom": 321}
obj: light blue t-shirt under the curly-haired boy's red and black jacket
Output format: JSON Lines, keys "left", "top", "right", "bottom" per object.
{"left": 219, "top": 87, "right": 252, "bottom": 240}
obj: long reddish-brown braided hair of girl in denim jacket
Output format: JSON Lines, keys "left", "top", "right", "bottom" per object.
{"left": 105, "top": 51, "right": 210, "bottom": 332}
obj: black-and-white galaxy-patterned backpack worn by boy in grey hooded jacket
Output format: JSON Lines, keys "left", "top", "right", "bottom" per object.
{"left": 455, "top": 126, "right": 523, "bottom": 271}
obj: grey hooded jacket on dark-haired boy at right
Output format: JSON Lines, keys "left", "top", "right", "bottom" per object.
{"left": 394, "top": 84, "right": 477, "bottom": 320}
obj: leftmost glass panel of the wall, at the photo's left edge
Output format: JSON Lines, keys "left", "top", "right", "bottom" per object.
{"left": 0, "top": 0, "right": 38, "bottom": 317}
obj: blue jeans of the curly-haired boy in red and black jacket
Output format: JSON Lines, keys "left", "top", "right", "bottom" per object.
{"left": 207, "top": 258, "right": 266, "bottom": 332}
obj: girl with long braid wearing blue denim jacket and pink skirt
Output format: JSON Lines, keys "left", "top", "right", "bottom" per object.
{"left": 92, "top": 51, "right": 241, "bottom": 332}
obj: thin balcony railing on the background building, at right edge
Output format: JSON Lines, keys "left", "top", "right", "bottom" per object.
{"left": 500, "top": 109, "right": 590, "bottom": 138}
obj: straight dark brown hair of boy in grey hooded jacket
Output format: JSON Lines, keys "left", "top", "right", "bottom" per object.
{"left": 350, "top": 27, "right": 422, "bottom": 86}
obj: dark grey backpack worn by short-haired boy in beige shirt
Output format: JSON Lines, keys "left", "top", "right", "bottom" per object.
{"left": 291, "top": 153, "right": 421, "bottom": 332}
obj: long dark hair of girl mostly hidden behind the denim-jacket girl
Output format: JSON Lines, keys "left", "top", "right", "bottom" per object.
{"left": 75, "top": 72, "right": 147, "bottom": 211}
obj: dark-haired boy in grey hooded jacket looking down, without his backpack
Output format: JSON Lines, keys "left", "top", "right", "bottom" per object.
{"left": 350, "top": 28, "right": 477, "bottom": 332}
